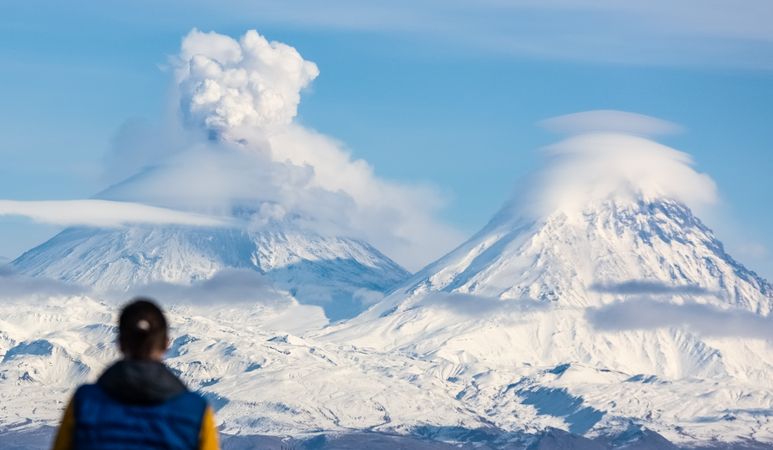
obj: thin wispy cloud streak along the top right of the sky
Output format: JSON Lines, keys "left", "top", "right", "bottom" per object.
{"left": 216, "top": 0, "right": 773, "bottom": 70}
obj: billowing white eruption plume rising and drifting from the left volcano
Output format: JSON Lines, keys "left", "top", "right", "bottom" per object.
{"left": 95, "top": 30, "right": 463, "bottom": 270}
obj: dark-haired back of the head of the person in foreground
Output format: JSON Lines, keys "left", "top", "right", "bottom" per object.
{"left": 118, "top": 298, "right": 168, "bottom": 359}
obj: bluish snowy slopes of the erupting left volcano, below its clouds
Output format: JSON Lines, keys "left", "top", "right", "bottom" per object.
{"left": 12, "top": 226, "right": 408, "bottom": 320}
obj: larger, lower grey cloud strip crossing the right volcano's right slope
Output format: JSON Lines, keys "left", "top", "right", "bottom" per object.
{"left": 586, "top": 299, "right": 773, "bottom": 340}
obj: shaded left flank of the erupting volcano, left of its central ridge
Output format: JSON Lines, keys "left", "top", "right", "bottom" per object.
{"left": 12, "top": 227, "right": 253, "bottom": 290}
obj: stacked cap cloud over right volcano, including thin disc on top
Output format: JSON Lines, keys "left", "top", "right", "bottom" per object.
{"left": 510, "top": 111, "right": 717, "bottom": 217}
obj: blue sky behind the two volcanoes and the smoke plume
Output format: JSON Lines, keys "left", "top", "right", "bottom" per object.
{"left": 0, "top": 0, "right": 773, "bottom": 278}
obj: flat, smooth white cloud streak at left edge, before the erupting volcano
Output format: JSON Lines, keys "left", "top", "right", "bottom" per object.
{"left": 0, "top": 200, "right": 231, "bottom": 227}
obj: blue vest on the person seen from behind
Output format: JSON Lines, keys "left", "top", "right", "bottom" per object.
{"left": 73, "top": 384, "right": 207, "bottom": 450}
